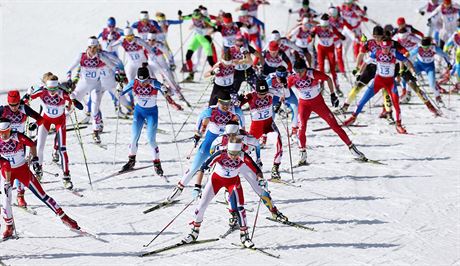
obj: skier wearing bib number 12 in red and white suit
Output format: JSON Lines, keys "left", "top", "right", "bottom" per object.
{"left": 241, "top": 79, "right": 283, "bottom": 179}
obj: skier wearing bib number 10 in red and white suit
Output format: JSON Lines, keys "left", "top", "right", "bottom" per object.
{"left": 30, "top": 75, "right": 82, "bottom": 190}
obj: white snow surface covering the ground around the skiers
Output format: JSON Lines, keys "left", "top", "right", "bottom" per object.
{"left": 0, "top": 0, "right": 460, "bottom": 265}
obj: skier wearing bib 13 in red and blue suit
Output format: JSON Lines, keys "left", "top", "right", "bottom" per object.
{"left": 344, "top": 37, "right": 415, "bottom": 134}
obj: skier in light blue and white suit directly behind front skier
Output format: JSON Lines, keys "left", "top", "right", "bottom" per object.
{"left": 167, "top": 92, "right": 242, "bottom": 201}
